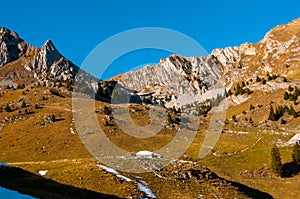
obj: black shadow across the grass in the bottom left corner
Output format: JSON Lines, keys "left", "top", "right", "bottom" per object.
{"left": 0, "top": 166, "right": 123, "bottom": 199}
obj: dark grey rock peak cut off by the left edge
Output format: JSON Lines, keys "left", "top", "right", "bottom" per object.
{"left": 0, "top": 27, "right": 28, "bottom": 67}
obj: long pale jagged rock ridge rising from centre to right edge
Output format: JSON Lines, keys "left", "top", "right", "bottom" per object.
{"left": 117, "top": 19, "right": 300, "bottom": 96}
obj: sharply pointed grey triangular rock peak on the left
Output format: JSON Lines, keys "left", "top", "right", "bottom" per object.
{"left": 26, "top": 40, "right": 78, "bottom": 80}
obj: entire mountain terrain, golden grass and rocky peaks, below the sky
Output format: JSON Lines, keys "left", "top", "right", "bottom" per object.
{"left": 0, "top": 19, "right": 300, "bottom": 198}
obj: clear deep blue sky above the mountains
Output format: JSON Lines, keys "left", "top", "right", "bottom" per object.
{"left": 0, "top": 0, "right": 300, "bottom": 77}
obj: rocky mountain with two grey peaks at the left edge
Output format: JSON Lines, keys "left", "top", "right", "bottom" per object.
{"left": 0, "top": 28, "right": 79, "bottom": 86}
